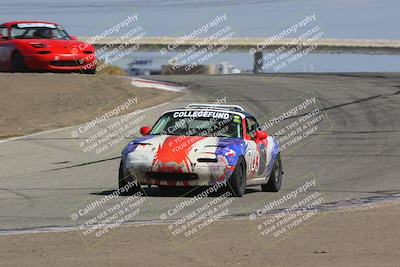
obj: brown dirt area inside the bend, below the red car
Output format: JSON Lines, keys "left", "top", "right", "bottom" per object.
{"left": 0, "top": 73, "right": 177, "bottom": 138}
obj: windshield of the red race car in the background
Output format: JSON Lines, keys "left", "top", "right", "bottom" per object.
{"left": 11, "top": 24, "right": 71, "bottom": 40}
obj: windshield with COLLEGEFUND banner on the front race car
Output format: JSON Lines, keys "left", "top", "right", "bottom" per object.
{"left": 150, "top": 110, "right": 242, "bottom": 138}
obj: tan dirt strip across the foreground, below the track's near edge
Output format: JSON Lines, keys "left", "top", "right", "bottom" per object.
{"left": 0, "top": 202, "right": 400, "bottom": 267}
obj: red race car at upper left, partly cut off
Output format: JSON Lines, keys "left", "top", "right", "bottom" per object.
{"left": 0, "top": 21, "right": 96, "bottom": 74}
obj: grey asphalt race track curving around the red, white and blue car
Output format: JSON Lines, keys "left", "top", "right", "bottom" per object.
{"left": 0, "top": 74, "right": 400, "bottom": 233}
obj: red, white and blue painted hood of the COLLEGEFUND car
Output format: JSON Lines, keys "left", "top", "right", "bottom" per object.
{"left": 122, "top": 135, "right": 246, "bottom": 171}
